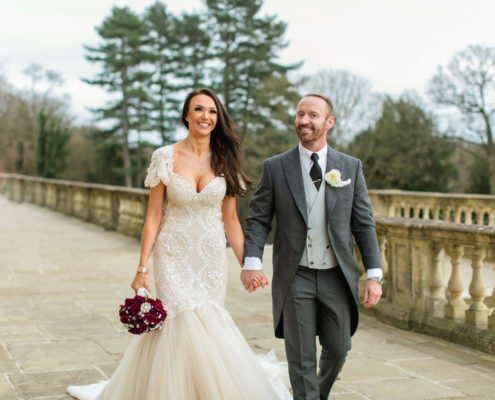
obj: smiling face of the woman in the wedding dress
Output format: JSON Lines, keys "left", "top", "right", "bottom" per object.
{"left": 186, "top": 94, "right": 218, "bottom": 136}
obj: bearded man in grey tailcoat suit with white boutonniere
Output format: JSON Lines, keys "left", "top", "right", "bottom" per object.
{"left": 241, "top": 94, "right": 382, "bottom": 400}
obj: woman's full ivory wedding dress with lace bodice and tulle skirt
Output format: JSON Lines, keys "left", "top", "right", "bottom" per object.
{"left": 68, "top": 146, "right": 292, "bottom": 400}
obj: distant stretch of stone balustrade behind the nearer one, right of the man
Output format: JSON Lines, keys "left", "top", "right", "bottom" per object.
{"left": 369, "top": 190, "right": 495, "bottom": 226}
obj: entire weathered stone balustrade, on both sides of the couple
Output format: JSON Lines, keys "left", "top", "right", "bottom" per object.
{"left": 0, "top": 173, "right": 495, "bottom": 353}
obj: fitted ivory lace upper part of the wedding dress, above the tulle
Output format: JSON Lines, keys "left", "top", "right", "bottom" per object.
{"left": 145, "top": 146, "right": 227, "bottom": 318}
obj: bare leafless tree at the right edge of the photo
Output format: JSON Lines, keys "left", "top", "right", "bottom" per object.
{"left": 428, "top": 45, "right": 495, "bottom": 194}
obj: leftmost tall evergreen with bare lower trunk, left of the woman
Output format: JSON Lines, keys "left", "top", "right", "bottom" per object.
{"left": 84, "top": 7, "right": 151, "bottom": 186}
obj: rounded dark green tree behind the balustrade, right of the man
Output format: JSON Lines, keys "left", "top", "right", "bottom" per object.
{"left": 349, "top": 98, "right": 455, "bottom": 192}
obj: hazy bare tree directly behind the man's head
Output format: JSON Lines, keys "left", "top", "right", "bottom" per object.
{"left": 303, "top": 69, "right": 382, "bottom": 143}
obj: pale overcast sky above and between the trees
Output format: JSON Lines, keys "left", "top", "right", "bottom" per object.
{"left": 0, "top": 0, "right": 495, "bottom": 123}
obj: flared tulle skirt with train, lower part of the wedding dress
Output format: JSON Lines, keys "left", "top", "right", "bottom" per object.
{"left": 67, "top": 304, "right": 292, "bottom": 400}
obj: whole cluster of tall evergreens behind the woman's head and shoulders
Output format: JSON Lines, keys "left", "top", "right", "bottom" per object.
{"left": 80, "top": 0, "right": 299, "bottom": 189}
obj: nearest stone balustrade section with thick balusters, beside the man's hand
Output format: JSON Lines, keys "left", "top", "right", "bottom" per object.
{"left": 366, "top": 217, "right": 495, "bottom": 354}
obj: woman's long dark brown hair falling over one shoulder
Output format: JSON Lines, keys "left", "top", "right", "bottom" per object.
{"left": 182, "top": 88, "right": 253, "bottom": 197}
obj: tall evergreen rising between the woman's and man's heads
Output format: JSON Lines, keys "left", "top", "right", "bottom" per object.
{"left": 206, "top": 0, "right": 298, "bottom": 140}
